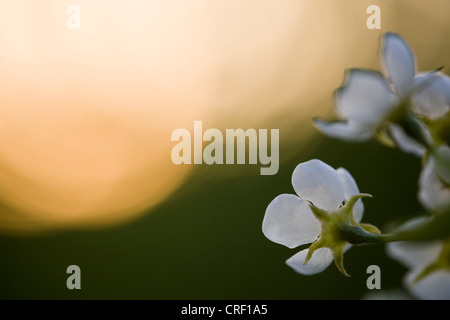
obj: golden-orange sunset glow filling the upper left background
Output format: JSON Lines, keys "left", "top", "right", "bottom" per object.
{"left": 0, "top": 0, "right": 450, "bottom": 231}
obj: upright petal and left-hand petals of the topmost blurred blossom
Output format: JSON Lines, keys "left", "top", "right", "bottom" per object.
{"left": 315, "top": 33, "right": 416, "bottom": 141}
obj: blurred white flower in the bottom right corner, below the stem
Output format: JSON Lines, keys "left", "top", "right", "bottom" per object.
{"left": 387, "top": 241, "right": 450, "bottom": 300}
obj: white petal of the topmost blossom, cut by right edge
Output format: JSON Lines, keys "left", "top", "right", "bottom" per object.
{"left": 412, "top": 72, "right": 450, "bottom": 119}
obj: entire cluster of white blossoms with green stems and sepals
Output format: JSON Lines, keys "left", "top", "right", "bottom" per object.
{"left": 263, "top": 33, "right": 450, "bottom": 299}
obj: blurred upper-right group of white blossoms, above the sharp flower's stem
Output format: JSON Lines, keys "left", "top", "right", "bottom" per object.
{"left": 314, "top": 33, "right": 450, "bottom": 211}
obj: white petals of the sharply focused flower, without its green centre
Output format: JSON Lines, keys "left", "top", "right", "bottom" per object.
{"left": 262, "top": 160, "right": 364, "bottom": 275}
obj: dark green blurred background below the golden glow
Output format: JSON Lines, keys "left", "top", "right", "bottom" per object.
{"left": 0, "top": 135, "right": 421, "bottom": 300}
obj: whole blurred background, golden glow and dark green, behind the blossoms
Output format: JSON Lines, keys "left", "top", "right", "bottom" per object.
{"left": 0, "top": 0, "right": 450, "bottom": 299}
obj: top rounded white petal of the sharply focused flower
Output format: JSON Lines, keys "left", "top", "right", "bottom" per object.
{"left": 292, "top": 159, "right": 345, "bottom": 211}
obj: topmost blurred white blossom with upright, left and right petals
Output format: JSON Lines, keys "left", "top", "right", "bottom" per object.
{"left": 314, "top": 33, "right": 450, "bottom": 143}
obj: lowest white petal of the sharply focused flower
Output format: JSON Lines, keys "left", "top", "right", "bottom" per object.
{"left": 286, "top": 248, "right": 333, "bottom": 276}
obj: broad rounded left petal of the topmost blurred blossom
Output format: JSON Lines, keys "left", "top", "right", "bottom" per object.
{"left": 334, "top": 69, "right": 398, "bottom": 122}
